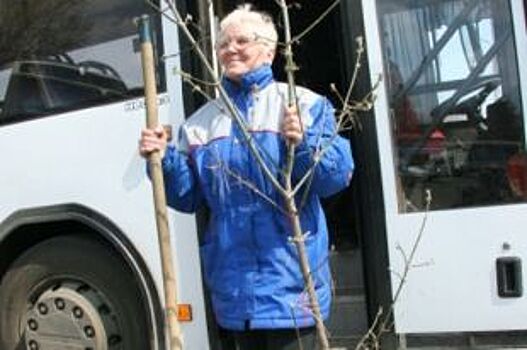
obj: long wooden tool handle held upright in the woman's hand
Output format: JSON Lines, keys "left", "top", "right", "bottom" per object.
{"left": 138, "top": 15, "right": 183, "bottom": 350}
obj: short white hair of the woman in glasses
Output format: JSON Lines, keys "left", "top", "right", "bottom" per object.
{"left": 220, "top": 3, "right": 278, "bottom": 51}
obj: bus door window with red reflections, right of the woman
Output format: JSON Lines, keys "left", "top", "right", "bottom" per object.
{"left": 378, "top": 0, "right": 526, "bottom": 212}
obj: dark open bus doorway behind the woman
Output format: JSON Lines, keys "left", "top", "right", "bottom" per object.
{"left": 209, "top": 0, "right": 368, "bottom": 349}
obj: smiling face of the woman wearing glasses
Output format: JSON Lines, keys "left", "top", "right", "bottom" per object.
{"left": 217, "top": 23, "right": 274, "bottom": 81}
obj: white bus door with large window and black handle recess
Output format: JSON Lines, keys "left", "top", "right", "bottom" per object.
{"left": 362, "top": 0, "right": 527, "bottom": 334}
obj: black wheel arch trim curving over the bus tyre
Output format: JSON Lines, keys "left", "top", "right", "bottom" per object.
{"left": 0, "top": 203, "right": 165, "bottom": 349}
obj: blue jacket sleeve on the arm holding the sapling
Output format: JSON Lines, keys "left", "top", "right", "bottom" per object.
{"left": 293, "top": 98, "right": 354, "bottom": 197}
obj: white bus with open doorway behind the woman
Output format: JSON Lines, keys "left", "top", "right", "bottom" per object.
{"left": 0, "top": 0, "right": 527, "bottom": 350}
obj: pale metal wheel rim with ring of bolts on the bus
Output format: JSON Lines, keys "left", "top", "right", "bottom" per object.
{"left": 24, "top": 281, "right": 122, "bottom": 350}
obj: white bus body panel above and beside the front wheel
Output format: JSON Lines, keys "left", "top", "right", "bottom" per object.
{"left": 0, "top": 95, "right": 207, "bottom": 348}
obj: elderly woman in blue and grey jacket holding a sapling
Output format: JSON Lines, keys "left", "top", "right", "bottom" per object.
{"left": 140, "top": 5, "right": 353, "bottom": 350}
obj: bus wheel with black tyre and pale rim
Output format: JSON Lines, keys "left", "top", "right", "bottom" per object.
{"left": 0, "top": 236, "right": 152, "bottom": 350}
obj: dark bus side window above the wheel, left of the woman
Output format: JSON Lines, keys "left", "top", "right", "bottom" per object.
{"left": 0, "top": 0, "right": 164, "bottom": 123}
